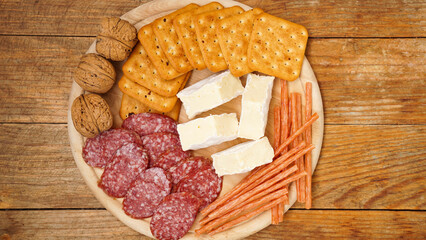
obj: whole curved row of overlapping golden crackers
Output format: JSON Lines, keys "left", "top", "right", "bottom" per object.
{"left": 119, "top": 2, "right": 308, "bottom": 119}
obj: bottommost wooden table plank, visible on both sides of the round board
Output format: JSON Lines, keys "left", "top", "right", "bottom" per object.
{"left": 0, "top": 210, "right": 426, "bottom": 240}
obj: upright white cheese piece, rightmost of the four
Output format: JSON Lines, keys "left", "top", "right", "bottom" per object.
{"left": 238, "top": 74, "right": 274, "bottom": 140}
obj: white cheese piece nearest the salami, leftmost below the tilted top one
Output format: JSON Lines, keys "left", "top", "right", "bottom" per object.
{"left": 177, "top": 113, "right": 238, "bottom": 151}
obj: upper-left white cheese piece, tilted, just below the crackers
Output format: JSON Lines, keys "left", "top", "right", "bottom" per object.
{"left": 177, "top": 70, "right": 244, "bottom": 118}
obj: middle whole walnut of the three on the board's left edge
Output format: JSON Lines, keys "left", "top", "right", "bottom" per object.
{"left": 74, "top": 53, "right": 116, "bottom": 93}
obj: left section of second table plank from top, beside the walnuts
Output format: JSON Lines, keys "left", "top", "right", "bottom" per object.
{"left": 0, "top": 37, "right": 94, "bottom": 123}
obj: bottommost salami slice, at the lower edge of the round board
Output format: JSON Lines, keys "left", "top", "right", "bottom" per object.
{"left": 150, "top": 192, "right": 200, "bottom": 240}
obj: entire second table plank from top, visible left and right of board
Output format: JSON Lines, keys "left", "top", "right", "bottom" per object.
{"left": 0, "top": 36, "right": 426, "bottom": 124}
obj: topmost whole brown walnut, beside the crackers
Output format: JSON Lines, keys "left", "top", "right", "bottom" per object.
{"left": 96, "top": 17, "right": 138, "bottom": 61}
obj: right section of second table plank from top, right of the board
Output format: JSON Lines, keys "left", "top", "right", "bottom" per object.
{"left": 306, "top": 39, "right": 426, "bottom": 124}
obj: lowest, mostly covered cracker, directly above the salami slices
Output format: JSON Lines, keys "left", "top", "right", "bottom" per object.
{"left": 120, "top": 93, "right": 182, "bottom": 121}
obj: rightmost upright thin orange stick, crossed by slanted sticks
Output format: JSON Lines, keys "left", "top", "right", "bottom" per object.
{"left": 305, "top": 82, "right": 312, "bottom": 209}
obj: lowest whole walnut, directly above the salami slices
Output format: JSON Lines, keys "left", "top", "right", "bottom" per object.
{"left": 71, "top": 94, "right": 113, "bottom": 138}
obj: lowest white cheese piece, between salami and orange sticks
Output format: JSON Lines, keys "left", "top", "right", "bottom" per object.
{"left": 212, "top": 137, "right": 274, "bottom": 176}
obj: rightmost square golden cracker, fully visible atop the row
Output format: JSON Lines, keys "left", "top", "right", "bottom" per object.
{"left": 248, "top": 13, "right": 308, "bottom": 81}
